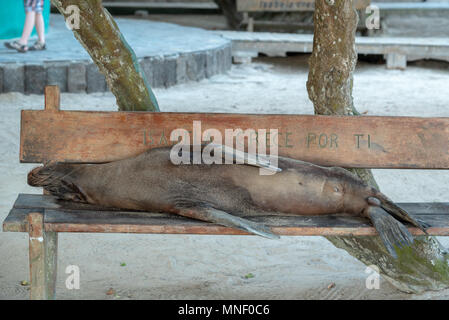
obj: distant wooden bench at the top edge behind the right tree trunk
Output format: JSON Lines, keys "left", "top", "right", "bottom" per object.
{"left": 237, "top": 0, "right": 370, "bottom": 32}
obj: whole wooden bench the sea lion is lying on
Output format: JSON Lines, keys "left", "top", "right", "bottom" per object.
{"left": 3, "top": 86, "right": 449, "bottom": 299}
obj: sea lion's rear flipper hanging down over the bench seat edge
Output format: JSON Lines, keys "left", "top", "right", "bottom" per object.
{"left": 365, "top": 206, "right": 413, "bottom": 258}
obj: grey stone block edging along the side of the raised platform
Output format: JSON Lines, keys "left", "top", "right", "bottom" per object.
{"left": 0, "top": 42, "right": 232, "bottom": 94}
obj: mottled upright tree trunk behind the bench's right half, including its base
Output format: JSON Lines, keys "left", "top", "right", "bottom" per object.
{"left": 307, "top": 0, "right": 449, "bottom": 292}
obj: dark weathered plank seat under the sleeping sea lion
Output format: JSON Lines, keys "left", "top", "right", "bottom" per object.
{"left": 3, "top": 194, "right": 449, "bottom": 236}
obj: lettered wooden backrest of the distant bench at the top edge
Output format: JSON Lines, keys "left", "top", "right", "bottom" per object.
{"left": 237, "top": 0, "right": 370, "bottom": 12}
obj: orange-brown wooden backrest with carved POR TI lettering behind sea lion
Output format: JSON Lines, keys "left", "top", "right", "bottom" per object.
{"left": 20, "top": 86, "right": 449, "bottom": 169}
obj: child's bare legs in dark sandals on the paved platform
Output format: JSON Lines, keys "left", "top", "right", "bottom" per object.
{"left": 5, "top": 0, "right": 45, "bottom": 53}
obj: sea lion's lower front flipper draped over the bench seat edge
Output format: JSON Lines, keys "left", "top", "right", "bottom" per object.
{"left": 178, "top": 206, "right": 280, "bottom": 239}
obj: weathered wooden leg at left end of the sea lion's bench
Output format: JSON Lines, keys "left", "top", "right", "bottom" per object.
{"left": 28, "top": 212, "right": 58, "bottom": 300}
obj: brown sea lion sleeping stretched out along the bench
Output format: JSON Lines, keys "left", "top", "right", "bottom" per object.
{"left": 28, "top": 147, "right": 426, "bottom": 256}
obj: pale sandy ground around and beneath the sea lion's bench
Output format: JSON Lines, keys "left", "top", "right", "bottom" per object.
{"left": 0, "top": 55, "right": 449, "bottom": 299}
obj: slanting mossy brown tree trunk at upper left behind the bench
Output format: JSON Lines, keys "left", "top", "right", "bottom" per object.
{"left": 51, "top": 0, "right": 159, "bottom": 111}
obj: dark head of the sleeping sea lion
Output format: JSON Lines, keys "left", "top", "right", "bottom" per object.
{"left": 27, "top": 163, "right": 87, "bottom": 202}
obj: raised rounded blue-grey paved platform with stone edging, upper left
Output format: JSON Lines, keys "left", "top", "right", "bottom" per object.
{"left": 0, "top": 15, "right": 231, "bottom": 93}
